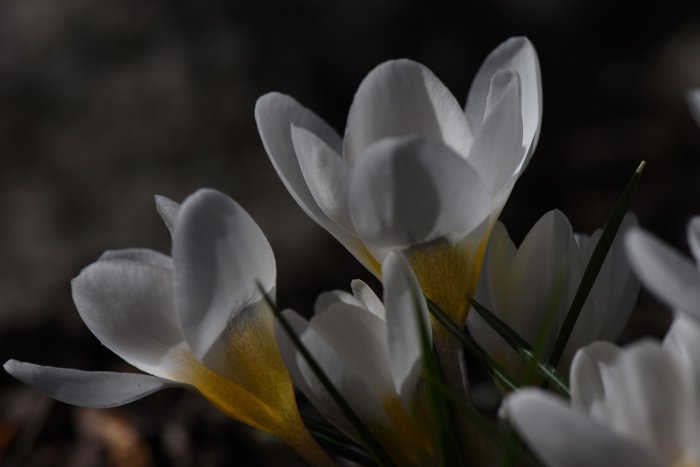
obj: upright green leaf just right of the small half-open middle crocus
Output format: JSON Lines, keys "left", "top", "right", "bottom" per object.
{"left": 412, "top": 278, "right": 464, "bottom": 467}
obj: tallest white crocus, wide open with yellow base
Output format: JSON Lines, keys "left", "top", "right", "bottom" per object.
{"left": 255, "top": 37, "right": 542, "bottom": 337}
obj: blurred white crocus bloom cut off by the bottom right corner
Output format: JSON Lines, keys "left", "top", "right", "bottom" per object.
{"left": 503, "top": 341, "right": 700, "bottom": 467}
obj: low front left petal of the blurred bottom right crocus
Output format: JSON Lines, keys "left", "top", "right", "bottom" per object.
{"left": 503, "top": 389, "right": 663, "bottom": 467}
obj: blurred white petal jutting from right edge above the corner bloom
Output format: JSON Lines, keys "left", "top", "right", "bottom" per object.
{"left": 625, "top": 228, "right": 700, "bottom": 320}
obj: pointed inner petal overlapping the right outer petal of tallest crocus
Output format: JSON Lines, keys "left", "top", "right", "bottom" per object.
{"left": 469, "top": 70, "right": 526, "bottom": 205}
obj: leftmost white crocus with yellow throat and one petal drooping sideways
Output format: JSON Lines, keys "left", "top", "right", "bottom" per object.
{"left": 4, "top": 189, "right": 332, "bottom": 465}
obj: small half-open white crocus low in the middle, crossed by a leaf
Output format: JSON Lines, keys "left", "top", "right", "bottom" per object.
{"left": 276, "top": 253, "right": 435, "bottom": 465}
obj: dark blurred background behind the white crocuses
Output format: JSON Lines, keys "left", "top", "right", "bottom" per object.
{"left": 0, "top": 0, "right": 700, "bottom": 467}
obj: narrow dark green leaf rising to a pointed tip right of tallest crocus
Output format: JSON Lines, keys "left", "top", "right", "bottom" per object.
{"left": 549, "top": 161, "right": 646, "bottom": 367}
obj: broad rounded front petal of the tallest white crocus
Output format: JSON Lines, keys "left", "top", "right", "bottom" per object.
{"left": 350, "top": 138, "right": 491, "bottom": 248}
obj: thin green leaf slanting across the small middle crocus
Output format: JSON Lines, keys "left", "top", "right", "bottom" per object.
{"left": 258, "top": 284, "right": 394, "bottom": 467}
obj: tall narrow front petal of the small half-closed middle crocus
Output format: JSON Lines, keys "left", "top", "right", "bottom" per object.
{"left": 382, "top": 252, "right": 432, "bottom": 408}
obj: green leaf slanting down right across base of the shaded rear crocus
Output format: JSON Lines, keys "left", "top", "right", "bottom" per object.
{"left": 469, "top": 298, "right": 571, "bottom": 397}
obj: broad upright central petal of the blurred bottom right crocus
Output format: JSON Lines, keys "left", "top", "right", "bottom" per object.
{"left": 603, "top": 341, "right": 699, "bottom": 465}
